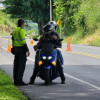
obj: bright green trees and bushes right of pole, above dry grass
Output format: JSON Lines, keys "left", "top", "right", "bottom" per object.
{"left": 54, "top": 0, "right": 100, "bottom": 39}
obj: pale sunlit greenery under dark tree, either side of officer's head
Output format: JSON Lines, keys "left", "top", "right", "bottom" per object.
{"left": 0, "top": 10, "right": 38, "bottom": 35}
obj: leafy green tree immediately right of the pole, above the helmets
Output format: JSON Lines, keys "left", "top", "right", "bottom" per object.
{"left": 54, "top": 0, "right": 80, "bottom": 36}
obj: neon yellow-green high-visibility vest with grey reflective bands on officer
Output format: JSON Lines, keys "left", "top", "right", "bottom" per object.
{"left": 12, "top": 27, "right": 26, "bottom": 47}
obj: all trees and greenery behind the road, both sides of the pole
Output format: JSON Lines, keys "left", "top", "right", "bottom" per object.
{"left": 0, "top": 0, "right": 100, "bottom": 45}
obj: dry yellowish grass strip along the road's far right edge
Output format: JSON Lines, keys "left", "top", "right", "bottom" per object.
{"left": 63, "top": 30, "right": 100, "bottom": 46}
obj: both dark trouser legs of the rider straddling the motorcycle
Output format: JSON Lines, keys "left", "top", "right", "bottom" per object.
{"left": 31, "top": 50, "right": 64, "bottom": 81}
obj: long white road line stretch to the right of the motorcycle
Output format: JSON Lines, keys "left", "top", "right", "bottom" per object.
{"left": 64, "top": 73, "right": 100, "bottom": 91}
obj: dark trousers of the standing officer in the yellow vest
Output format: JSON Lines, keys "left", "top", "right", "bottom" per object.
{"left": 13, "top": 47, "right": 26, "bottom": 83}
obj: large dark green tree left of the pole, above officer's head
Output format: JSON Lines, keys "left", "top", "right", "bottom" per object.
{"left": 3, "top": 0, "right": 50, "bottom": 34}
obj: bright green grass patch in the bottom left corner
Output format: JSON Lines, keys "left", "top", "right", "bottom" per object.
{"left": 0, "top": 69, "right": 28, "bottom": 100}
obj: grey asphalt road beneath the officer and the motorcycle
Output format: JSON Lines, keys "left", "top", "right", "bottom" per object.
{"left": 0, "top": 36, "right": 100, "bottom": 100}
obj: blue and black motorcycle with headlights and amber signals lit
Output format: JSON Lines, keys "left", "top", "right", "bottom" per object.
{"left": 38, "top": 43, "right": 59, "bottom": 85}
